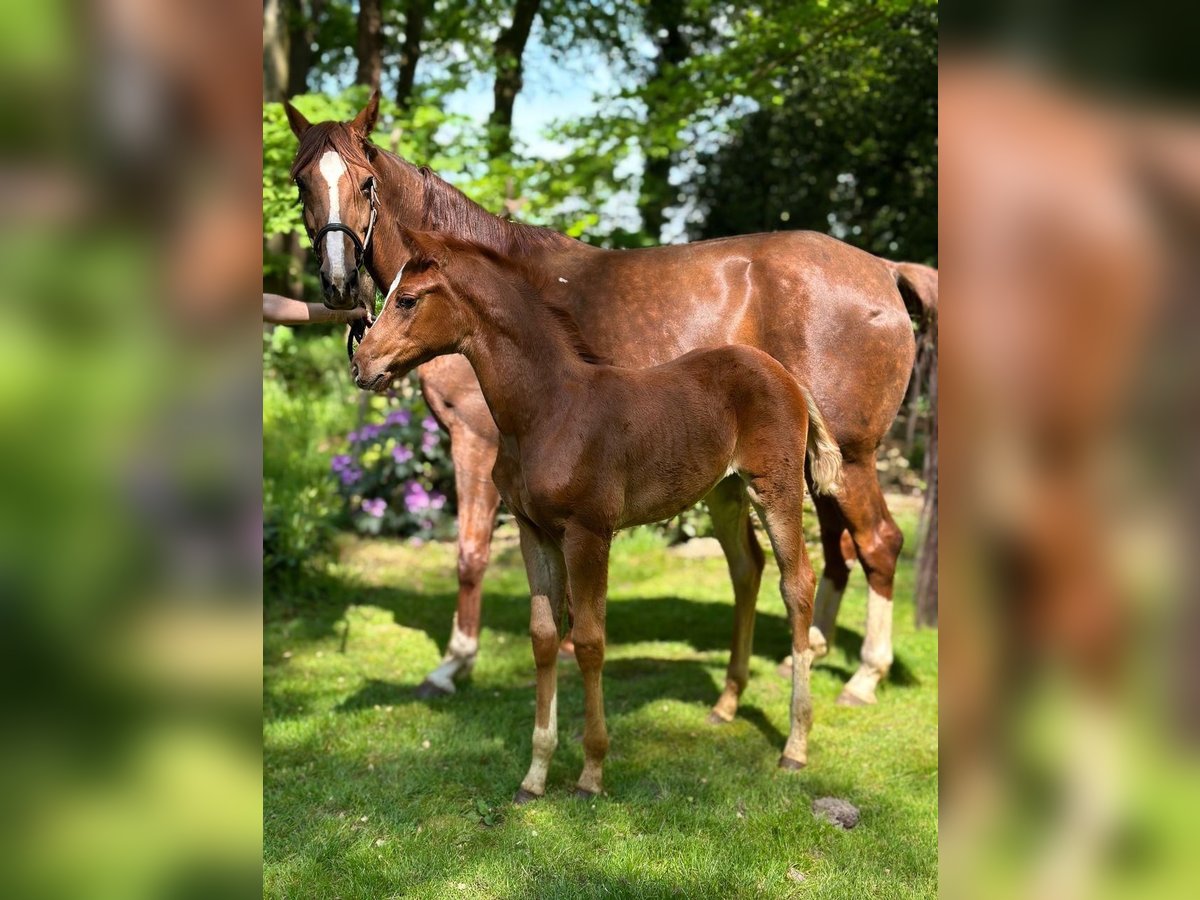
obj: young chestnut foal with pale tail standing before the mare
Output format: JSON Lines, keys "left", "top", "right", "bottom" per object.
{"left": 353, "top": 232, "right": 841, "bottom": 803}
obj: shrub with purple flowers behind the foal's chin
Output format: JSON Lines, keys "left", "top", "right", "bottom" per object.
{"left": 330, "top": 382, "right": 455, "bottom": 540}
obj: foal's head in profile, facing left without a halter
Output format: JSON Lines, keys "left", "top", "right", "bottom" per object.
{"left": 350, "top": 229, "right": 476, "bottom": 390}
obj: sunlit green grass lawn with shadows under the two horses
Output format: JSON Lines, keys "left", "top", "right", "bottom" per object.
{"left": 264, "top": 496, "right": 937, "bottom": 900}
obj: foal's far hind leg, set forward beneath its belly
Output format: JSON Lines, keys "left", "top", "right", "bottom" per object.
{"left": 704, "top": 476, "right": 764, "bottom": 725}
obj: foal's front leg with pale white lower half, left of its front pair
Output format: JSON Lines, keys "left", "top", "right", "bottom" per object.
{"left": 512, "top": 523, "right": 566, "bottom": 803}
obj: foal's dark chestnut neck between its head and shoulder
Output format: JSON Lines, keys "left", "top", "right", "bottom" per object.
{"left": 462, "top": 284, "right": 593, "bottom": 437}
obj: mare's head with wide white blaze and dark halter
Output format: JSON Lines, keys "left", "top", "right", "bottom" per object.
{"left": 286, "top": 92, "right": 379, "bottom": 310}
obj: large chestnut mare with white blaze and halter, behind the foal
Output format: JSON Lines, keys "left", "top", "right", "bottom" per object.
{"left": 287, "top": 96, "right": 920, "bottom": 706}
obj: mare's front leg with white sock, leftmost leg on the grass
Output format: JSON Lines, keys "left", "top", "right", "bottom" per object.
{"left": 416, "top": 427, "right": 500, "bottom": 697}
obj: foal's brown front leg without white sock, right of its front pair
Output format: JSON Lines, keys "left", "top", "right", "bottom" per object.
{"left": 563, "top": 526, "right": 612, "bottom": 797}
